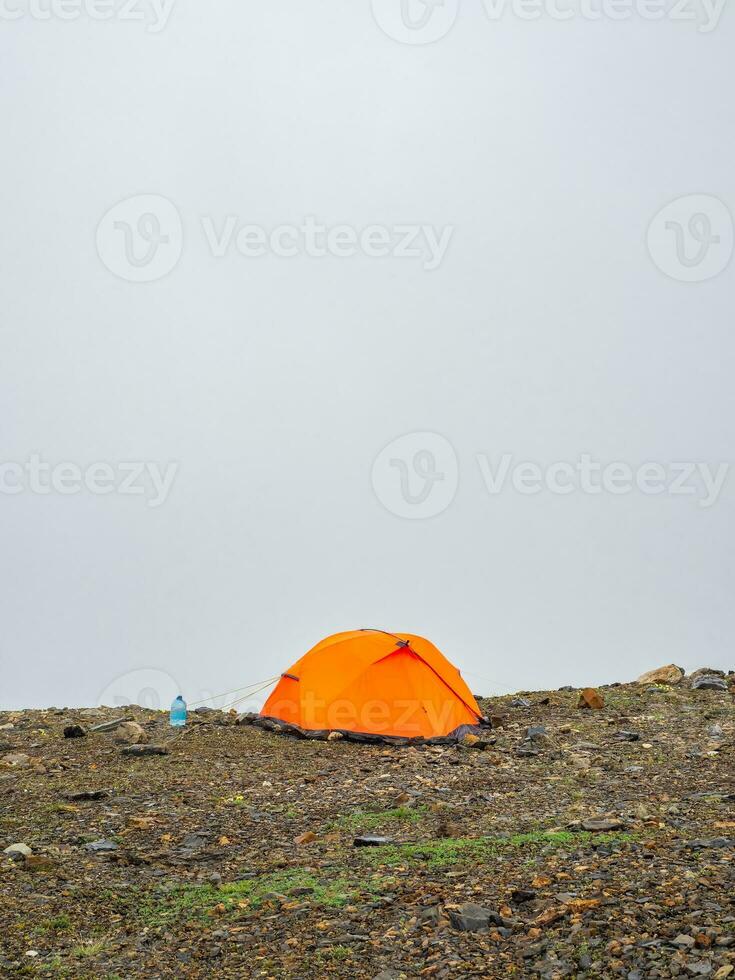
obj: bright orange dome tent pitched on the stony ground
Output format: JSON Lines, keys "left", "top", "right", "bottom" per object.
{"left": 260, "top": 630, "right": 482, "bottom": 739}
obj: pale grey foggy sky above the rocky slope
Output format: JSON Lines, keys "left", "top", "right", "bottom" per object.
{"left": 0, "top": 0, "right": 735, "bottom": 707}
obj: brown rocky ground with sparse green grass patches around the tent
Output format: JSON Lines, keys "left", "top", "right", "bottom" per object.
{"left": 0, "top": 675, "right": 735, "bottom": 980}
